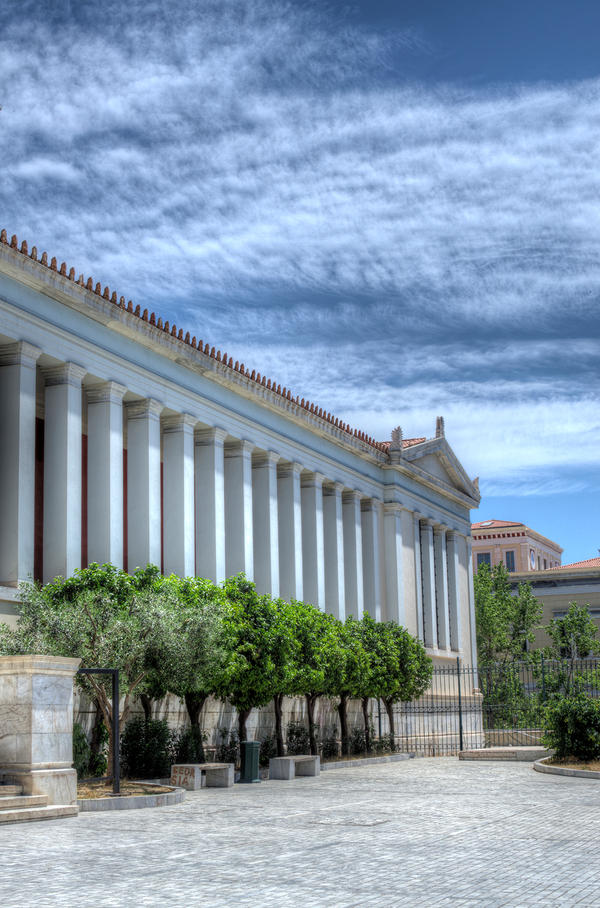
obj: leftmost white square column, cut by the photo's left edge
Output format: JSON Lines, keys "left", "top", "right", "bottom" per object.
{"left": 0, "top": 341, "right": 42, "bottom": 586}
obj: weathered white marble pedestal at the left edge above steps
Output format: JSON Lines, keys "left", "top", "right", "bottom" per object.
{"left": 0, "top": 656, "right": 81, "bottom": 804}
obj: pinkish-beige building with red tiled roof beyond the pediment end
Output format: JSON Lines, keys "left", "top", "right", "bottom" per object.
{"left": 471, "top": 520, "right": 563, "bottom": 573}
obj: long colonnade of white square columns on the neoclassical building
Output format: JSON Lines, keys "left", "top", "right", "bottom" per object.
{"left": 0, "top": 341, "right": 461, "bottom": 653}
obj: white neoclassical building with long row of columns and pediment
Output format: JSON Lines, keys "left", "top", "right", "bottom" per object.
{"left": 0, "top": 231, "right": 479, "bottom": 663}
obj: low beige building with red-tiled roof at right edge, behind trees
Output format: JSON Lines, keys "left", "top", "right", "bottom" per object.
{"left": 511, "top": 558, "right": 600, "bottom": 648}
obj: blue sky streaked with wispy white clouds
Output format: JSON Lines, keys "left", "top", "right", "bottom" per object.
{"left": 0, "top": 0, "right": 600, "bottom": 562}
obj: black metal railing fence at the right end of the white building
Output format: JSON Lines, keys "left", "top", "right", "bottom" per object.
{"left": 394, "top": 656, "right": 600, "bottom": 756}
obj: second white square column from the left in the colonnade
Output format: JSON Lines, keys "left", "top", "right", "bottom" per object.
{"left": 43, "top": 363, "right": 85, "bottom": 583}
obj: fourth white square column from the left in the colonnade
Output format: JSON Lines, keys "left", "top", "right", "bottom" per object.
{"left": 125, "top": 398, "right": 163, "bottom": 574}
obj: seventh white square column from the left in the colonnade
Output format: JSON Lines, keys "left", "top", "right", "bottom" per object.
{"left": 225, "top": 441, "right": 254, "bottom": 580}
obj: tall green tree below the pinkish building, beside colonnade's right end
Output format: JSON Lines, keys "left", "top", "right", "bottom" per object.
{"left": 474, "top": 564, "right": 543, "bottom": 665}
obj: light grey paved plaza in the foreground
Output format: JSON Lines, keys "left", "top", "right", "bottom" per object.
{"left": 0, "top": 758, "right": 600, "bottom": 908}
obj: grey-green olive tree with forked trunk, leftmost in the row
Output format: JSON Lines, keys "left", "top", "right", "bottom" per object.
{"left": 0, "top": 565, "right": 181, "bottom": 773}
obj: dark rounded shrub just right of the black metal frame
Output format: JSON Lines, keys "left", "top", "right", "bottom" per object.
{"left": 121, "top": 717, "right": 175, "bottom": 779}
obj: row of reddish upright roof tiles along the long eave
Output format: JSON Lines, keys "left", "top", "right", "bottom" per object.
{"left": 0, "top": 229, "right": 390, "bottom": 454}
